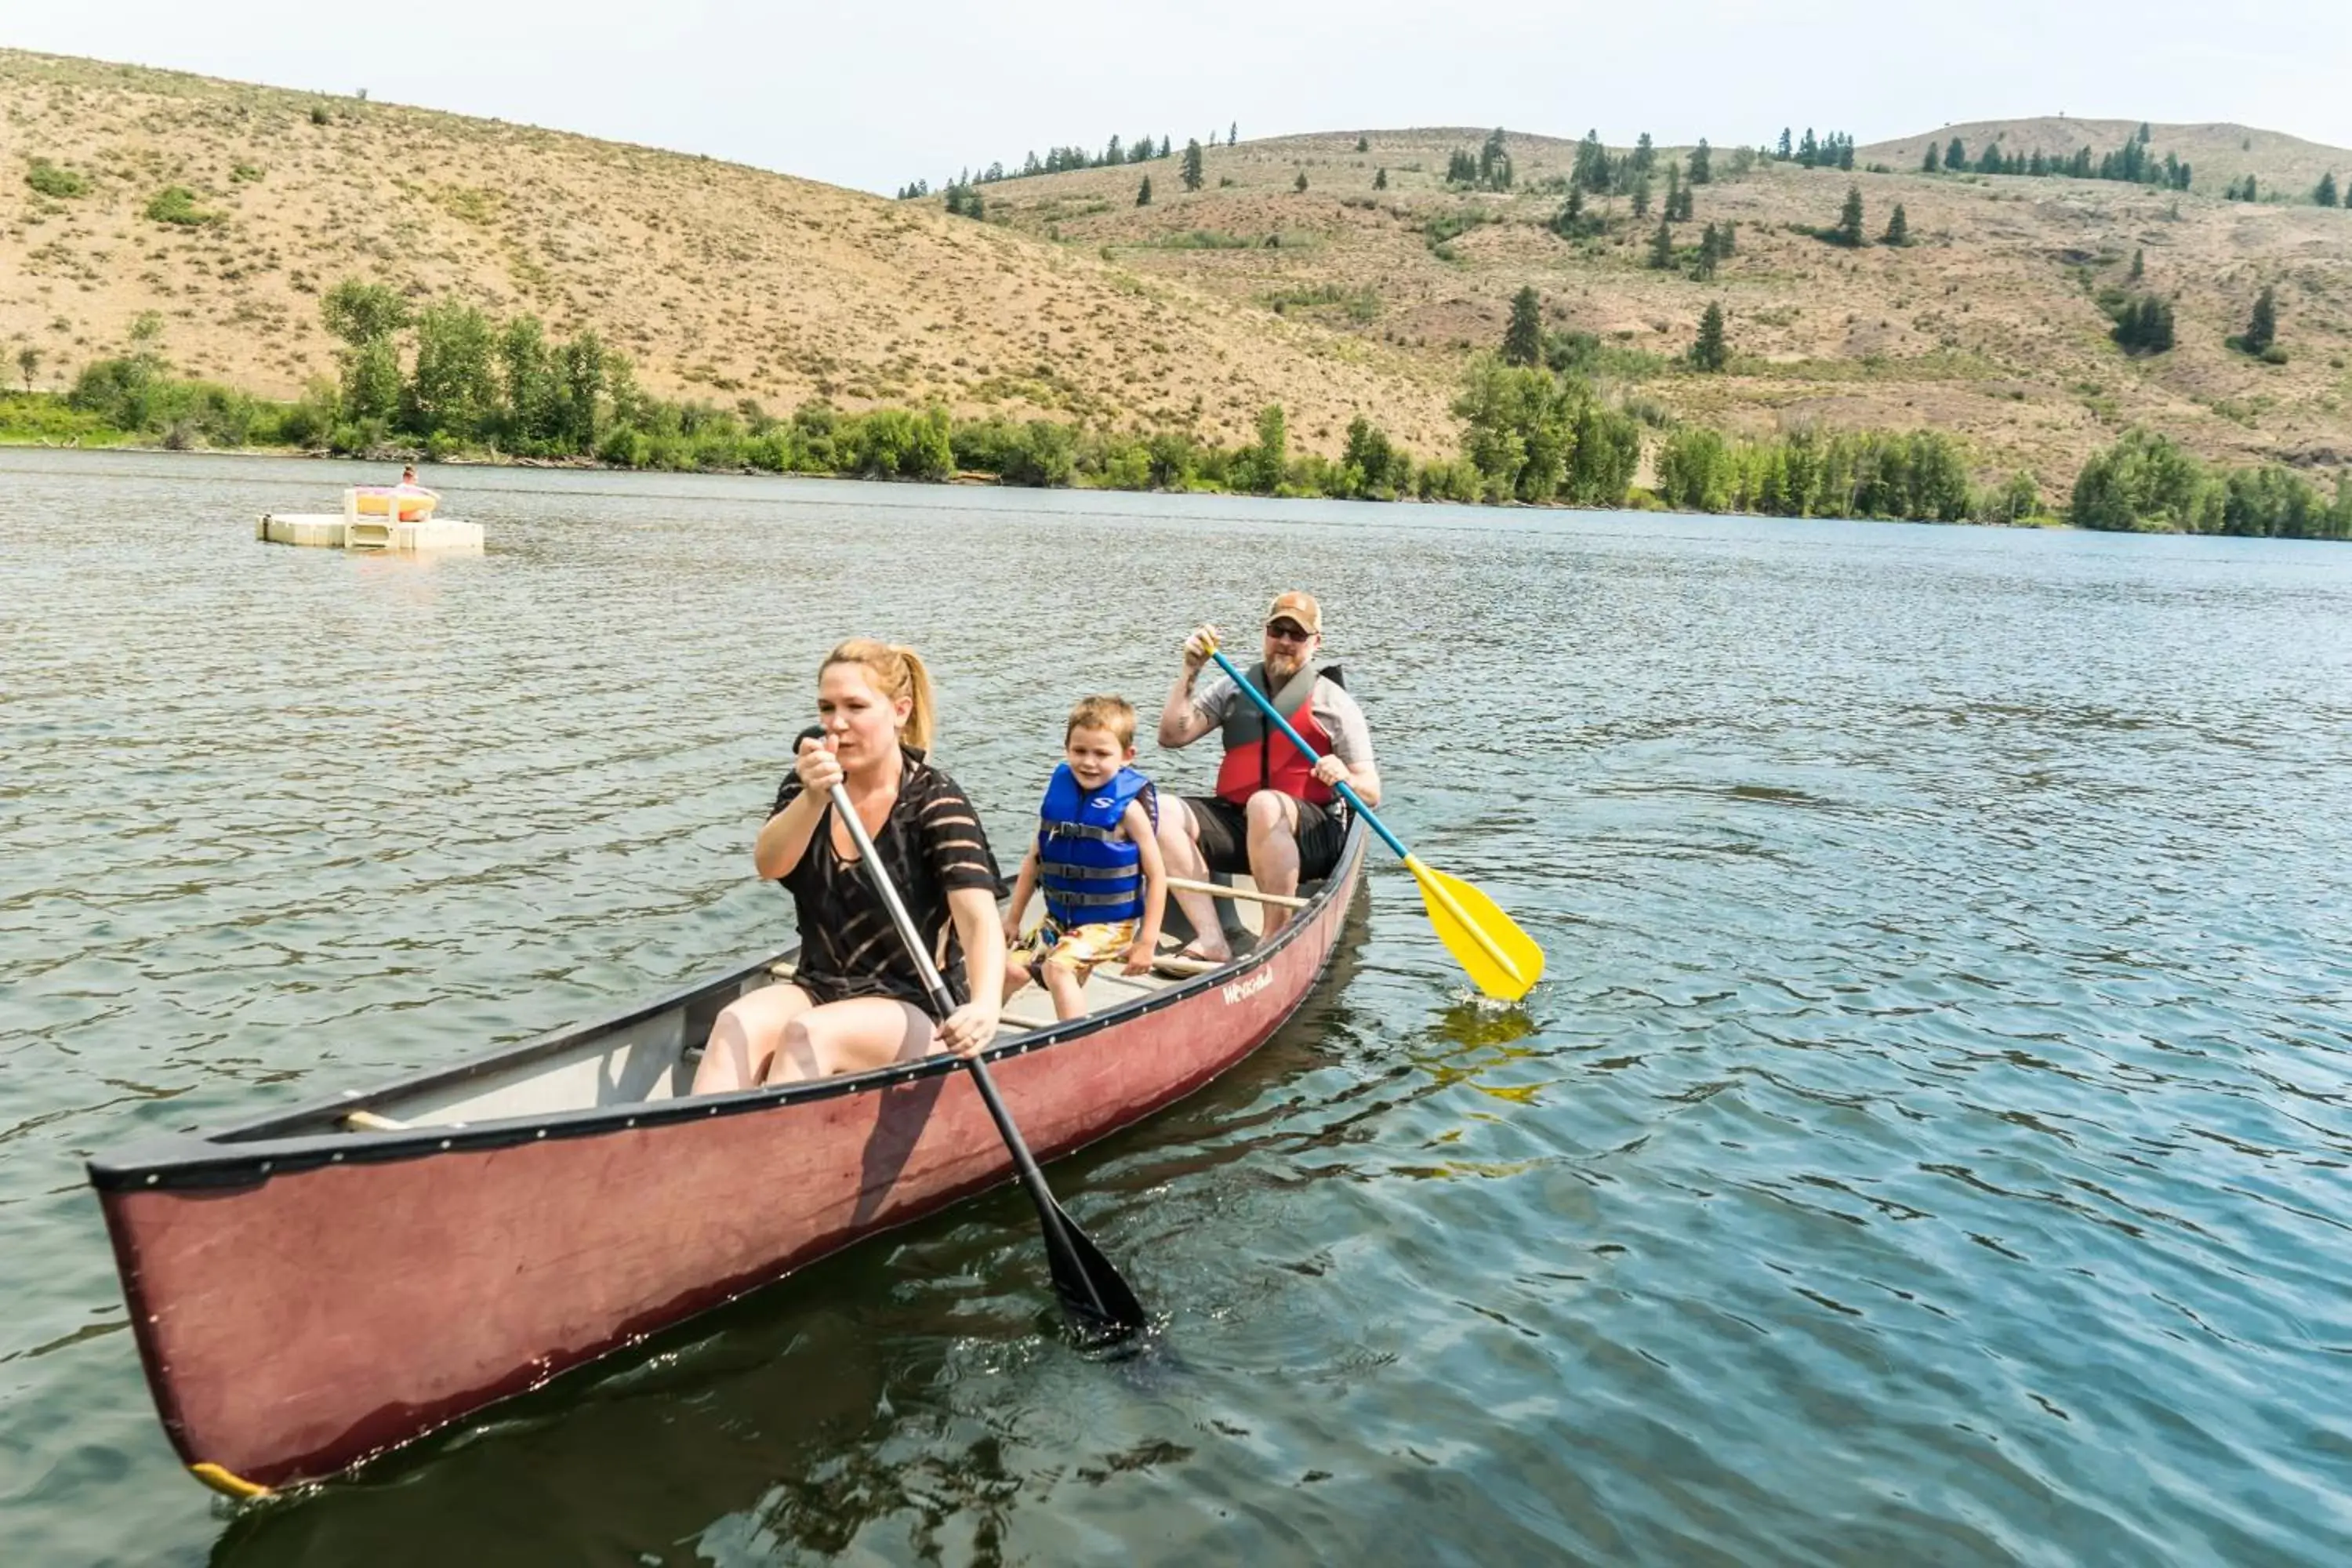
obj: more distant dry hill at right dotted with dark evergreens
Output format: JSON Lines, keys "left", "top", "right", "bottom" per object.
{"left": 983, "top": 120, "right": 2352, "bottom": 485}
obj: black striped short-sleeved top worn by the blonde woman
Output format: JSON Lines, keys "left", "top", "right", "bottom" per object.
{"left": 769, "top": 746, "right": 1000, "bottom": 1013}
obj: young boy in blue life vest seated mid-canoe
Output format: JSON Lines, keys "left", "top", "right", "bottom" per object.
{"left": 1004, "top": 696, "right": 1169, "bottom": 1018}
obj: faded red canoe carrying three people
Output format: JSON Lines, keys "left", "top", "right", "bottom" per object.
{"left": 89, "top": 827, "right": 1364, "bottom": 1495}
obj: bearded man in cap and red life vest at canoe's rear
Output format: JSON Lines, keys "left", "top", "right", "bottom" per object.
{"left": 1160, "top": 590, "right": 1381, "bottom": 968}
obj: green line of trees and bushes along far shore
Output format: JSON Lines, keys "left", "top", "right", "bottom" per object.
{"left": 0, "top": 280, "right": 2352, "bottom": 539}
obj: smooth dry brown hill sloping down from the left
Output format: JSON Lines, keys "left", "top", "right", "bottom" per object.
{"left": 0, "top": 52, "right": 1454, "bottom": 452}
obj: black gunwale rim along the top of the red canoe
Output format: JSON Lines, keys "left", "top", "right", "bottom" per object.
{"left": 85, "top": 822, "right": 1367, "bottom": 1192}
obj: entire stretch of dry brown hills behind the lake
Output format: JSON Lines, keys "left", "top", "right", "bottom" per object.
{"left": 0, "top": 52, "right": 2352, "bottom": 492}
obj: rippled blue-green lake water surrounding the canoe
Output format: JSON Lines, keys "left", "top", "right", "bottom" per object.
{"left": 0, "top": 452, "right": 2352, "bottom": 1566}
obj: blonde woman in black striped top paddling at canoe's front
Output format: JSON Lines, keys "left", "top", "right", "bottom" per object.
{"left": 694, "top": 637, "right": 1004, "bottom": 1093}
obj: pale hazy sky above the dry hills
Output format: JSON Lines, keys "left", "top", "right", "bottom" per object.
{"left": 0, "top": 0, "right": 2352, "bottom": 191}
